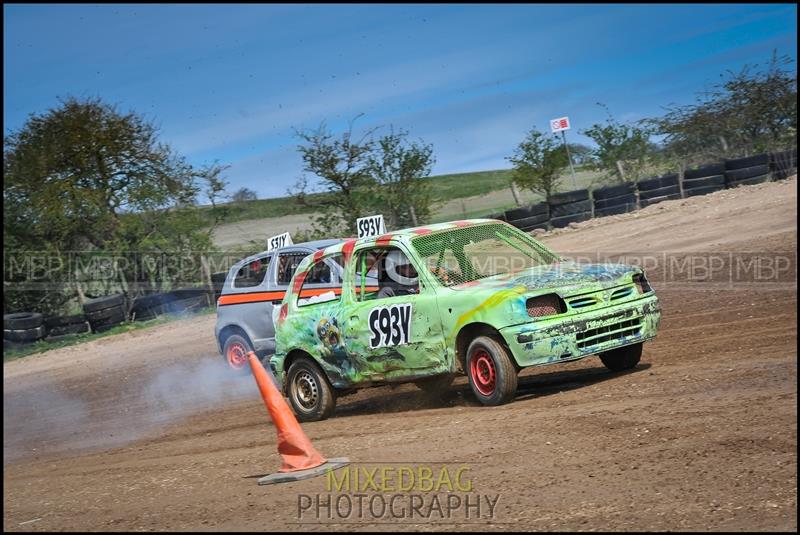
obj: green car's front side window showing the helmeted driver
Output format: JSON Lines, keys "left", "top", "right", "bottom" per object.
{"left": 354, "top": 247, "right": 420, "bottom": 301}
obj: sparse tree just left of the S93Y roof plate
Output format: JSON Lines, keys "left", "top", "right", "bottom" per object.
{"left": 290, "top": 115, "right": 375, "bottom": 236}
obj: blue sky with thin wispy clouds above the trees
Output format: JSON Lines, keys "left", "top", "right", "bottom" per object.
{"left": 3, "top": 4, "right": 797, "bottom": 201}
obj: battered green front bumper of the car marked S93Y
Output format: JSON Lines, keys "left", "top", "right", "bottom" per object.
{"left": 500, "top": 294, "right": 661, "bottom": 367}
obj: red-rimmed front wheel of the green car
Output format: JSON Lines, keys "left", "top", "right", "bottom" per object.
{"left": 466, "top": 336, "right": 517, "bottom": 405}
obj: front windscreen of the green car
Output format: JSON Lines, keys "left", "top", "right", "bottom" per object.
{"left": 411, "top": 223, "right": 558, "bottom": 286}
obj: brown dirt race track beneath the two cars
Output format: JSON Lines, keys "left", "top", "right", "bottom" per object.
{"left": 3, "top": 179, "right": 797, "bottom": 531}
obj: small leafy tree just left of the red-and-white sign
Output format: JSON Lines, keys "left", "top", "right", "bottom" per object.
{"left": 506, "top": 127, "right": 569, "bottom": 199}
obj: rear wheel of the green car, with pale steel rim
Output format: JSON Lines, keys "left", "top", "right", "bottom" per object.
{"left": 286, "top": 358, "right": 336, "bottom": 422}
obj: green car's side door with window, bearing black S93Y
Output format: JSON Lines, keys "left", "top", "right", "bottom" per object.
{"left": 342, "top": 246, "right": 449, "bottom": 379}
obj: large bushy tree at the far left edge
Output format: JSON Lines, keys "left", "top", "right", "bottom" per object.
{"left": 3, "top": 98, "right": 225, "bottom": 312}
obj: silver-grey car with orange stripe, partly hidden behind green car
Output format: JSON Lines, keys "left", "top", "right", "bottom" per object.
{"left": 214, "top": 239, "right": 342, "bottom": 371}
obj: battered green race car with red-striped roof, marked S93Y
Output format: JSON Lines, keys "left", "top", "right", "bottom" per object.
{"left": 270, "top": 219, "right": 661, "bottom": 421}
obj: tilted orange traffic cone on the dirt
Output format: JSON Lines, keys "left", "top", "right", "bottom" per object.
{"left": 247, "top": 351, "right": 350, "bottom": 485}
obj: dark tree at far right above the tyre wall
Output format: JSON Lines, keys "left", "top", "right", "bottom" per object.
{"left": 645, "top": 53, "right": 797, "bottom": 163}
